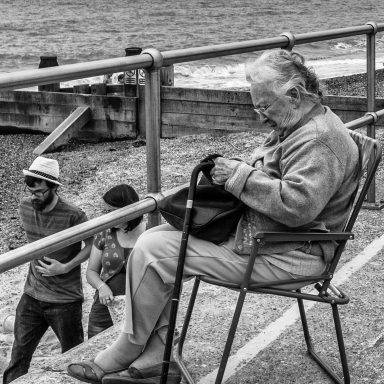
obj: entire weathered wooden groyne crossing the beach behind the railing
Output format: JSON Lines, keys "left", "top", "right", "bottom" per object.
{"left": 0, "top": 75, "right": 384, "bottom": 152}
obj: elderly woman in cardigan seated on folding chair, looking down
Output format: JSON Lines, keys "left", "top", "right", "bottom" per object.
{"left": 68, "top": 50, "right": 359, "bottom": 383}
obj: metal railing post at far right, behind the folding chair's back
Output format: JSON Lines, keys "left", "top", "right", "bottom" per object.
{"left": 366, "top": 21, "right": 377, "bottom": 204}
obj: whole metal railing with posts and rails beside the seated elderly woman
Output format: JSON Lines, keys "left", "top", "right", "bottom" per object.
{"left": 0, "top": 22, "right": 384, "bottom": 273}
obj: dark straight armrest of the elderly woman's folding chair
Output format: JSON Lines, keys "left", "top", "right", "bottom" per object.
{"left": 253, "top": 232, "right": 355, "bottom": 243}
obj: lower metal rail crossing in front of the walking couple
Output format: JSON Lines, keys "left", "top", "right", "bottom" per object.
{"left": 0, "top": 184, "right": 188, "bottom": 273}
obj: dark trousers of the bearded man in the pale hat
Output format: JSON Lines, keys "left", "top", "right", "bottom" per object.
{"left": 3, "top": 294, "right": 84, "bottom": 384}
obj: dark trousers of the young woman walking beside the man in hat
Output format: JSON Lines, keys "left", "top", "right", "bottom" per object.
{"left": 88, "top": 268, "right": 126, "bottom": 339}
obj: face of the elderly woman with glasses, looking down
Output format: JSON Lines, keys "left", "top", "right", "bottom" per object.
{"left": 251, "top": 83, "right": 300, "bottom": 132}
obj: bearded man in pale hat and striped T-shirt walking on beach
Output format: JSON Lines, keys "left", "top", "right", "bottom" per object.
{"left": 3, "top": 156, "right": 92, "bottom": 384}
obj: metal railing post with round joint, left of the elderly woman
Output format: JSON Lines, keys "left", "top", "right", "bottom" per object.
{"left": 142, "top": 48, "right": 163, "bottom": 228}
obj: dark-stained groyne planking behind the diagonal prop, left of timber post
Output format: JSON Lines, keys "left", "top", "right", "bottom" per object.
{"left": 0, "top": 86, "right": 137, "bottom": 141}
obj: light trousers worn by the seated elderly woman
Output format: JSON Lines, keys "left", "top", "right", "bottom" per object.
{"left": 123, "top": 224, "right": 312, "bottom": 345}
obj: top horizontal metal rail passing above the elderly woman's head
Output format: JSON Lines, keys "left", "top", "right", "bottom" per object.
{"left": 0, "top": 23, "right": 384, "bottom": 90}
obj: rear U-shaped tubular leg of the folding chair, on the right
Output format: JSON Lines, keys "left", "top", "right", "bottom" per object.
{"left": 297, "top": 299, "right": 350, "bottom": 384}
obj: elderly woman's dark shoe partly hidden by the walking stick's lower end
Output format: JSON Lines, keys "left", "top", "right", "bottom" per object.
{"left": 102, "top": 362, "right": 181, "bottom": 384}
